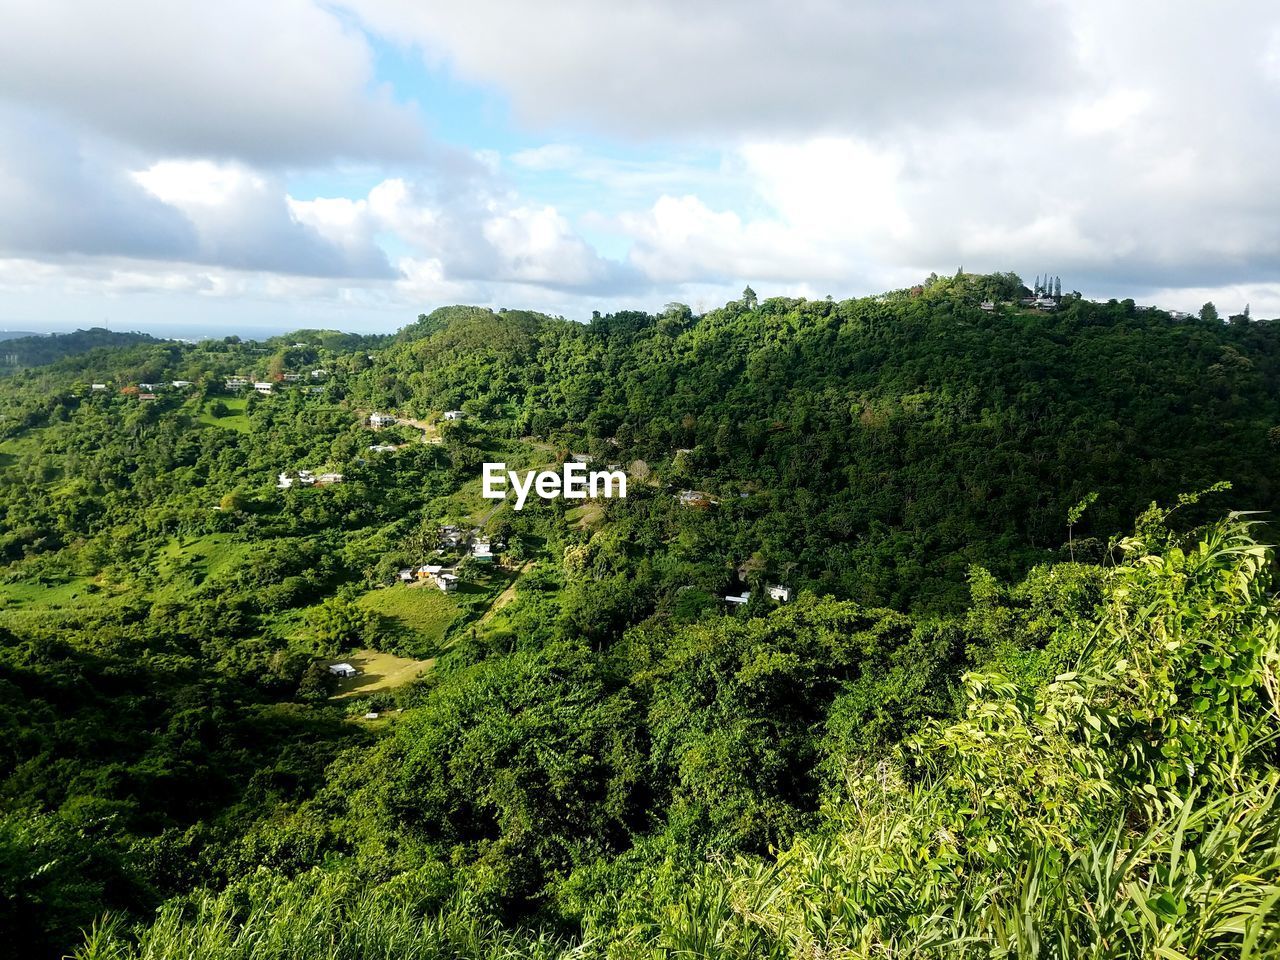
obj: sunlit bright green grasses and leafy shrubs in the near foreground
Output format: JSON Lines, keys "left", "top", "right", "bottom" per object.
{"left": 77, "top": 518, "right": 1280, "bottom": 960}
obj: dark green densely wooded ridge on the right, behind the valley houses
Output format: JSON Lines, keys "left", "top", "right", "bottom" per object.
{"left": 349, "top": 283, "right": 1280, "bottom": 605}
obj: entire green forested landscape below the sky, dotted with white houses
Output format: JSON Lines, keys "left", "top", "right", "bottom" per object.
{"left": 0, "top": 274, "right": 1280, "bottom": 960}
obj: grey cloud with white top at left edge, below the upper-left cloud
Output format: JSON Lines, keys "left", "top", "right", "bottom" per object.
{"left": 0, "top": 108, "right": 396, "bottom": 278}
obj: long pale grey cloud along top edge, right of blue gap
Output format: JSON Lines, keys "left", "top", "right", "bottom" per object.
{"left": 346, "top": 0, "right": 1073, "bottom": 140}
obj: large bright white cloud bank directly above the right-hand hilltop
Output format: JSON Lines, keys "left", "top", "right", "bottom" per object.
{"left": 586, "top": 4, "right": 1280, "bottom": 312}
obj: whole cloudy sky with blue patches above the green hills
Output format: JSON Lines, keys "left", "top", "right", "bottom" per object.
{"left": 0, "top": 0, "right": 1280, "bottom": 335}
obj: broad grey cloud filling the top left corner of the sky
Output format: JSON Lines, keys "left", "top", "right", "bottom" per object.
{"left": 0, "top": 0, "right": 426, "bottom": 164}
